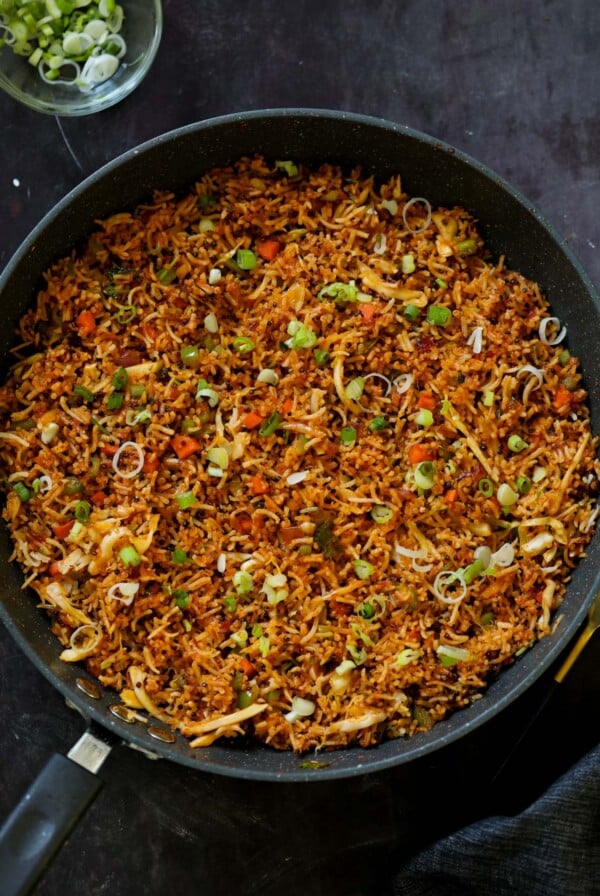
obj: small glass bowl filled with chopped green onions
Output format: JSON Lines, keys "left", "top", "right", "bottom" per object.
{"left": 0, "top": 0, "right": 162, "bottom": 116}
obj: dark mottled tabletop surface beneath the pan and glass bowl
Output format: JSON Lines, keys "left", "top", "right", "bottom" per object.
{"left": 0, "top": 0, "right": 600, "bottom": 896}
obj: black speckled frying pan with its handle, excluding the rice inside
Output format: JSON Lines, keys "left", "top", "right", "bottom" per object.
{"left": 0, "top": 109, "right": 600, "bottom": 896}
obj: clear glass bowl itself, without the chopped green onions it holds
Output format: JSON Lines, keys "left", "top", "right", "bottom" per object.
{"left": 0, "top": 0, "right": 162, "bottom": 116}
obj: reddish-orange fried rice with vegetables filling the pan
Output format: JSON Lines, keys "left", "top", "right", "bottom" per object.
{"left": 0, "top": 157, "right": 599, "bottom": 751}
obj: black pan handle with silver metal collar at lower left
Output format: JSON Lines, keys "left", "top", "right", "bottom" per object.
{"left": 0, "top": 732, "right": 110, "bottom": 896}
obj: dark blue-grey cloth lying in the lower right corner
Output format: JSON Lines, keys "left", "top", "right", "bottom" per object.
{"left": 394, "top": 745, "right": 600, "bottom": 896}
